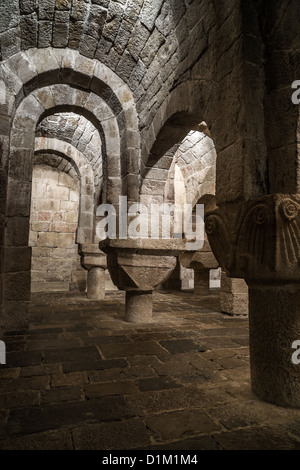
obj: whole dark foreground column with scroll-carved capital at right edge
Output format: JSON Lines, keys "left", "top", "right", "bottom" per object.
{"left": 206, "top": 194, "right": 300, "bottom": 408}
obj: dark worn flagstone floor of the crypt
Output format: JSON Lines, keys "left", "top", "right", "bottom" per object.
{"left": 0, "top": 291, "right": 300, "bottom": 450}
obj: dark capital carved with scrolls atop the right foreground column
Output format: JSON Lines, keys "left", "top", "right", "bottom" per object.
{"left": 205, "top": 194, "right": 300, "bottom": 282}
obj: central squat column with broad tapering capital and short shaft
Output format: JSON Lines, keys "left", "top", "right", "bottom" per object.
{"left": 99, "top": 239, "right": 180, "bottom": 323}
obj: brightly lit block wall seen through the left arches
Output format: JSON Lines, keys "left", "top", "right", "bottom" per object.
{"left": 29, "top": 165, "right": 86, "bottom": 292}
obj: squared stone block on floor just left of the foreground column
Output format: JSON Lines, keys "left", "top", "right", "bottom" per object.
{"left": 220, "top": 271, "right": 248, "bottom": 315}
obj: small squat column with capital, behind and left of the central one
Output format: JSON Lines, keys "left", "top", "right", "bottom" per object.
{"left": 79, "top": 244, "right": 107, "bottom": 300}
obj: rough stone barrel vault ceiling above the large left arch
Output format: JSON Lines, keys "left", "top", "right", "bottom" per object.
{"left": 0, "top": 0, "right": 215, "bottom": 127}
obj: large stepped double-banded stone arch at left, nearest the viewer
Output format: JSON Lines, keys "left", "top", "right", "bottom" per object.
{"left": 1, "top": 48, "right": 140, "bottom": 327}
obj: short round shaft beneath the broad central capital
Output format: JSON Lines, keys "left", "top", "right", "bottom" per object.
{"left": 125, "top": 291, "right": 153, "bottom": 323}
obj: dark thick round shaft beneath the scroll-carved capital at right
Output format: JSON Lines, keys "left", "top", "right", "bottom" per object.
{"left": 249, "top": 283, "right": 300, "bottom": 408}
